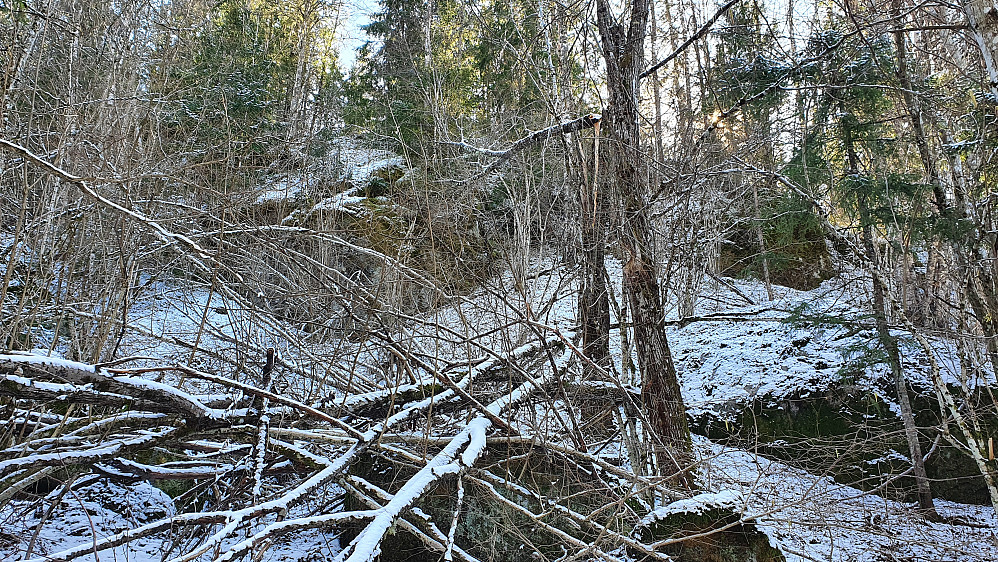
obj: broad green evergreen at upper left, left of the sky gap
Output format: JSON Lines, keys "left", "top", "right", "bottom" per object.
{"left": 152, "top": 0, "right": 331, "bottom": 168}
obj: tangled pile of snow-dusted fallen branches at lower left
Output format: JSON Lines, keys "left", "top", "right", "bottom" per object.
{"left": 0, "top": 330, "right": 688, "bottom": 562}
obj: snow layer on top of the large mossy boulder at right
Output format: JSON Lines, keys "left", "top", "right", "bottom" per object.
{"left": 669, "top": 278, "right": 904, "bottom": 421}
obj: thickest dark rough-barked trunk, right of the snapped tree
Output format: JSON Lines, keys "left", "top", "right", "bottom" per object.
{"left": 596, "top": 0, "right": 691, "bottom": 481}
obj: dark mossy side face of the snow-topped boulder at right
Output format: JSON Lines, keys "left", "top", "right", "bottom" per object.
{"left": 694, "top": 383, "right": 998, "bottom": 505}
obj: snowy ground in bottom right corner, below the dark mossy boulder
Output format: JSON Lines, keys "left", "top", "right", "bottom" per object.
{"left": 698, "top": 438, "right": 998, "bottom": 562}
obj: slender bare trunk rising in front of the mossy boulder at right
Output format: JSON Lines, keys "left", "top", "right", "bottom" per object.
{"left": 843, "top": 125, "right": 939, "bottom": 519}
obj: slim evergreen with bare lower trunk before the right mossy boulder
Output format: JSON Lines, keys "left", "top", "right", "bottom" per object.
{"left": 803, "top": 16, "right": 937, "bottom": 518}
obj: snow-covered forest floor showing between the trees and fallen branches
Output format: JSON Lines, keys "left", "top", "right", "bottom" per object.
{"left": 0, "top": 255, "right": 998, "bottom": 562}
